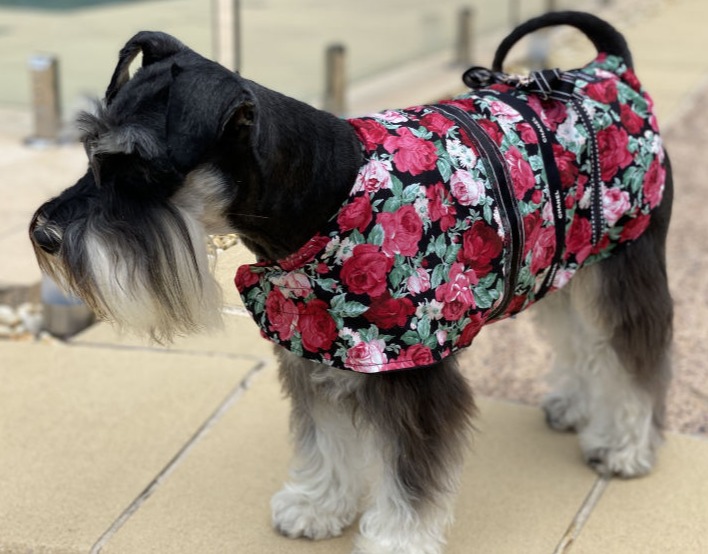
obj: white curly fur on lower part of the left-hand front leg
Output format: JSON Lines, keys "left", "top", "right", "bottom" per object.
{"left": 271, "top": 400, "right": 365, "bottom": 539}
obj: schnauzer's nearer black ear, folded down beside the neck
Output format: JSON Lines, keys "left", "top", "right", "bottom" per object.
{"left": 167, "top": 60, "right": 256, "bottom": 171}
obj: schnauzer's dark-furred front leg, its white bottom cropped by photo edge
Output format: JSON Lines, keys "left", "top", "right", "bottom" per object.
{"left": 355, "top": 358, "right": 474, "bottom": 554}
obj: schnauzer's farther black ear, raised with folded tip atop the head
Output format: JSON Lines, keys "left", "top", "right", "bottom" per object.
{"left": 106, "top": 31, "right": 187, "bottom": 104}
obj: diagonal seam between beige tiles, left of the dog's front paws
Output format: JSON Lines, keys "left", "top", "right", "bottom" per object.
{"left": 89, "top": 361, "right": 268, "bottom": 554}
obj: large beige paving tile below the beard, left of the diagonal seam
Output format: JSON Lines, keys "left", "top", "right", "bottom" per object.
{"left": 0, "top": 342, "right": 254, "bottom": 554}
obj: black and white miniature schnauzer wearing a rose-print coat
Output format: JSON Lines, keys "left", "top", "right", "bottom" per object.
{"left": 30, "top": 12, "right": 672, "bottom": 554}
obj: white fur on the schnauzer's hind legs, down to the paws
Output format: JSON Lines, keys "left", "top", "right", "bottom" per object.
{"left": 539, "top": 268, "right": 660, "bottom": 477}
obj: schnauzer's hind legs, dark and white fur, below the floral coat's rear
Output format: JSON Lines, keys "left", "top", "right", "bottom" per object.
{"left": 542, "top": 161, "right": 673, "bottom": 477}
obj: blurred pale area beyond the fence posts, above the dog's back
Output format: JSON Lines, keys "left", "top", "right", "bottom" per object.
{"left": 0, "top": 0, "right": 606, "bottom": 118}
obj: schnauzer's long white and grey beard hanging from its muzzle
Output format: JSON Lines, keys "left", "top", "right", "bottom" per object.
{"left": 35, "top": 206, "right": 221, "bottom": 342}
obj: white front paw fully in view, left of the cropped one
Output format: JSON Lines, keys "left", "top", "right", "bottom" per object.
{"left": 270, "top": 486, "right": 357, "bottom": 540}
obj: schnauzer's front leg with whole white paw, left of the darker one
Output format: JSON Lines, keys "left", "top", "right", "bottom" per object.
{"left": 271, "top": 349, "right": 367, "bottom": 539}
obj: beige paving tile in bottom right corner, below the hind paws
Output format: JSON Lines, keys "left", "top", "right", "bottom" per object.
{"left": 572, "top": 435, "right": 708, "bottom": 554}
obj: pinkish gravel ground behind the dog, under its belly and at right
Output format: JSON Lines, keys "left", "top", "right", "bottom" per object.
{"left": 461, "top": 84, "right": 708, "bottom": 437}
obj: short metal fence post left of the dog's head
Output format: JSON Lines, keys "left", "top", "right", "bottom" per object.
{"left": 29, "top": 54, "right": 61, "bottom": 142}
